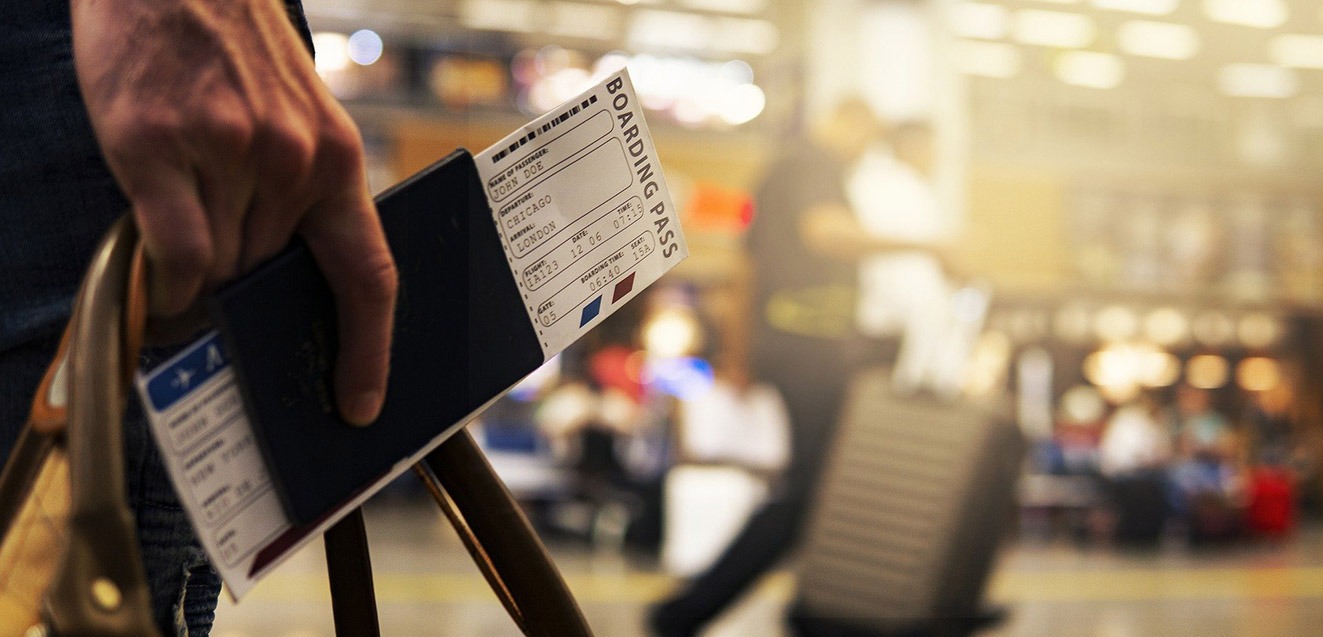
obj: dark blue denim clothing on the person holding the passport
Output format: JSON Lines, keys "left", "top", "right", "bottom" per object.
{"left": 0, "top": 0, "right": 308, "bottom": 637}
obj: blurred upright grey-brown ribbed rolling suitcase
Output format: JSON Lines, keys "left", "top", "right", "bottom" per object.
{"left": 790, "top": 371, "right": 1025, "bottom": 637}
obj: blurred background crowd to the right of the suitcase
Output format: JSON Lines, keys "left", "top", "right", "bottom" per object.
{"left": 1024, "top": 383, "right": 1312, "bottom": 544}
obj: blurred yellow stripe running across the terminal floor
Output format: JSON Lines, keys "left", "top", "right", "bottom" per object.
{"left": 230, "top": 567, "right": 1323, "bottom": 604}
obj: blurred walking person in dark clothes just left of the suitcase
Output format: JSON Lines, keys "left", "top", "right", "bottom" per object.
{"left": 650, "top": 98, "right": 947, "bottom": 636}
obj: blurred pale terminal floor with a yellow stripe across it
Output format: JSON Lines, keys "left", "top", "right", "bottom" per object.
{"left": 213, "top": 502, "right": 1323, "bottom": 637}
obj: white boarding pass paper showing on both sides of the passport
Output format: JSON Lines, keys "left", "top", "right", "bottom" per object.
{"left": 136, "top": 70, "right": 688, "bottom": 599}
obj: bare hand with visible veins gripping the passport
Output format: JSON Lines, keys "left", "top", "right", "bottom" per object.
{"left": 71, "top": 0, "right": 397, "bottom": 424}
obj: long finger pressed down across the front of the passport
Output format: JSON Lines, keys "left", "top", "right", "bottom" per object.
{"left": 299, "top": 188, "right": 398, "bottom": 425}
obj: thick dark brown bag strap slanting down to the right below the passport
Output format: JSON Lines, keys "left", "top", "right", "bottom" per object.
{"left": 419, "top": 429, "right": 593, "bottom": 637}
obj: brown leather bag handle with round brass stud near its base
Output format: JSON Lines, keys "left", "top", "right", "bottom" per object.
{"left": 45, "top": 216, "right": 159, "bottom": 637}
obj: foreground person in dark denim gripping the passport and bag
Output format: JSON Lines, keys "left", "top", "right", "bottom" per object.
{"left": 0, "top": 0, "right": 397, "bottom": 637}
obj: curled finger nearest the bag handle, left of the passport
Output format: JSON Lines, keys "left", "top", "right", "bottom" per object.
{"left": 124, "top": 167, "right": 214, "bottom": 317}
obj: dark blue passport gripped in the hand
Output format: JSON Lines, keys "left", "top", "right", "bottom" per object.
{"left": 209, "top": 150, "right": 542, "bottom": 524}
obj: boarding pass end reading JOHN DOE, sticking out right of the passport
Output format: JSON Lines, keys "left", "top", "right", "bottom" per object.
{"left": 475, "top": 69, "right": 689, "bottom": 358}
